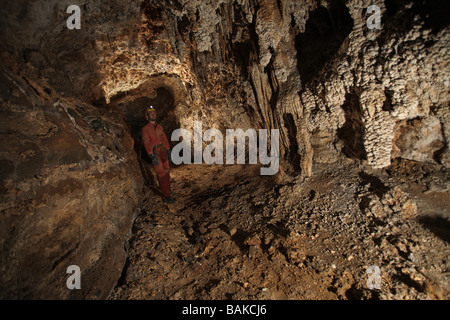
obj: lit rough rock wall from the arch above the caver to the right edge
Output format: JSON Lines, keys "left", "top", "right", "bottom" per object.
{"left": 93, "top": 0, "right": 449, "bottom": 175}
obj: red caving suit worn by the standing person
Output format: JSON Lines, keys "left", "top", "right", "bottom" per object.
{"left": 142, "top": 123, "right": 170, "bottom": 198}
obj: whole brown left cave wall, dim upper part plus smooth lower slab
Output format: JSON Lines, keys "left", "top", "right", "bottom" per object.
{"left": 0, "top": 1, "right": 144, "bottom": 299}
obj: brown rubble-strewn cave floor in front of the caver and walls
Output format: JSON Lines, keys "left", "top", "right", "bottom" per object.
{"left": 109, "top": 159, "right": 450, "bottom": 300}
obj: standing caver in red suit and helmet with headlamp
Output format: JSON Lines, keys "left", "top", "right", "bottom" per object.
{"left": 142, "top": 106, "right": 174, "bottom": 203}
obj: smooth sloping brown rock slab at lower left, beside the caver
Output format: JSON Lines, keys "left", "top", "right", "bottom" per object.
{"left": 0, "top": 71, "right": 143, "bottom": 299}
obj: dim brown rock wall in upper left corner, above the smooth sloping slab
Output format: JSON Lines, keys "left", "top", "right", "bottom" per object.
{"left": 0, "top": 0, "right": 140, "bottom": 102}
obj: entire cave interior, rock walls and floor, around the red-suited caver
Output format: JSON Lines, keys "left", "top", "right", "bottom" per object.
{"left": 0, "top": 0, "right": 450, "bottom": 300}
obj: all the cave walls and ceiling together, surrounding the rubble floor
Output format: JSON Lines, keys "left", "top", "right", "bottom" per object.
{"left": 0, "top": 0, "right": 450, "bottom": 298}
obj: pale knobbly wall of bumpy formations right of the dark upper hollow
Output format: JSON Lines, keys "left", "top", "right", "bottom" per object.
{"left": 301, "top": 1, "right": 449, "bottom": 168}
